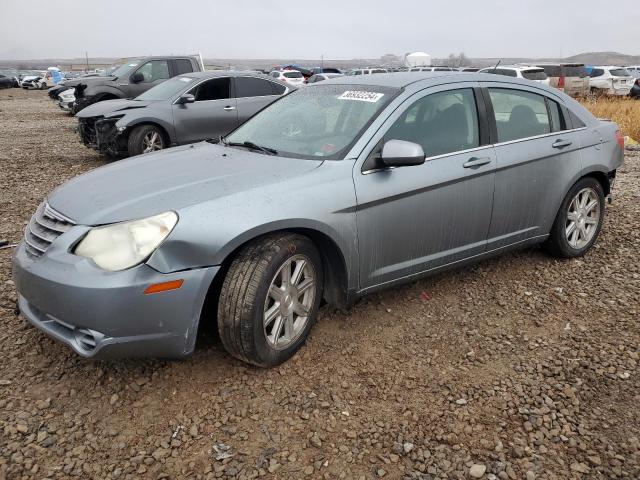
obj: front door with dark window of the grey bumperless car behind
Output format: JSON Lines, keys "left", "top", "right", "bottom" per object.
{"left": 172, "top": 77, "right": 238, "bottom": 144}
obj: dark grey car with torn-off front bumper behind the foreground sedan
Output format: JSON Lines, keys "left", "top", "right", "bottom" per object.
{"left": 76, "top": 71, "right": 290, "bottom": 157}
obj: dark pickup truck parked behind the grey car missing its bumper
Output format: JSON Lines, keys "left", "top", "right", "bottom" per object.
{"left": 58, "top": 56, "right": 202, "bottom": 113}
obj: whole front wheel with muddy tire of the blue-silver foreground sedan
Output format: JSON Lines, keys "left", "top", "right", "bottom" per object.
{"left": 218, "top": 233, "right": 323, "bottom": 367}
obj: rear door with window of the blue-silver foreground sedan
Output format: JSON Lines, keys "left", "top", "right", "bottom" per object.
{"left": 482, "top": 82, "right": 581, "bottom": 250}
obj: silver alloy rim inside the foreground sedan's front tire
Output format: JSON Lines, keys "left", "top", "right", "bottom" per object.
{"left": 263, "top": 255, "right": 317, "bottom": 350}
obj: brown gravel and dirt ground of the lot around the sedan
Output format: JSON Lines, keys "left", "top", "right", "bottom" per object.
{"left": 0, "top": 90, "right": 640, "bottom": 480}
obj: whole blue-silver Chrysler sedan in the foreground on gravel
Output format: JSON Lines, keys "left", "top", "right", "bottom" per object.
{"left": 13, "top": 73, "right": 623, "bottom": 366}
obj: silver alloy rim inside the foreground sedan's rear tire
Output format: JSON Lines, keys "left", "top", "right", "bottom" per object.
{"left": 565, "top": 188, "right": 601, "bottom": 250}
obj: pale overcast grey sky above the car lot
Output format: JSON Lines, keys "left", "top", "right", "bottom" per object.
{"left": 0, "top": 0, "right": 640, "bottom": 59}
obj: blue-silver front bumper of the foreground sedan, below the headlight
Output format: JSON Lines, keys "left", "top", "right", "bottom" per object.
{"left": 13, "top": 236, "right": 219, "bottom": 359}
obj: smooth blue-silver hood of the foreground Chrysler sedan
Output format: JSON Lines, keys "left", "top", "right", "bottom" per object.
{"left": 48, "top": 142, "right": 322, "bottom": 225}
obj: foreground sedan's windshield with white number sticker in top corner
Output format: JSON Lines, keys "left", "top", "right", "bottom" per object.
{"left": 225, "top": 85, "right": 399, "bottom": 159}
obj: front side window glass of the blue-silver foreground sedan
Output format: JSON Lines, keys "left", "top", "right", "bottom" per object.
{"left": 384, "top": 88, "right": 480, "bottom": 157}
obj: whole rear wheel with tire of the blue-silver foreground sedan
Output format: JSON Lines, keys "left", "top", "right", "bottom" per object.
{"left": 544, "top": 177, "right": 605, "bottom": 258}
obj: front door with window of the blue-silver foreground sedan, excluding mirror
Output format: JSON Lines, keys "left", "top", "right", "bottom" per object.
{"left": 354, "top": 82, "right": 496, "bottom": 290}
